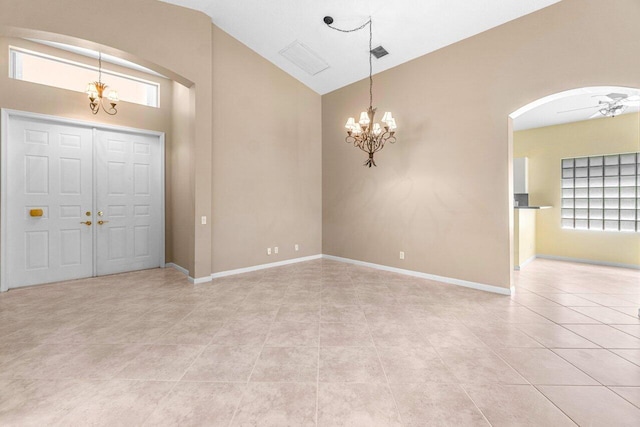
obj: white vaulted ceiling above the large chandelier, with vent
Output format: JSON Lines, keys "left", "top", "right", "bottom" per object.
{"left": 160, "top": 0, "right": 560, "bottom": 94}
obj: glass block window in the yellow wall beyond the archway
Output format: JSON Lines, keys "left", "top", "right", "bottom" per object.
{"left": 561, "top": 153, "right": 640, "bottom": 232}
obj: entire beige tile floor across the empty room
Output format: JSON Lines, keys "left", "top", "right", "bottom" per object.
{"left": 0, "top": 260, "right": 640, "bottom": 426}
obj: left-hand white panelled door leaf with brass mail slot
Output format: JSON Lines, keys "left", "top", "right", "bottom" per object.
{"left": 6, "top": 118, "right": 93, "bottom": 287}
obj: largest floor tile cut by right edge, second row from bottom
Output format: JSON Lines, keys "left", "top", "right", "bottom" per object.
{"left": 553, "top": 349, "right": 640, "bottom": 386}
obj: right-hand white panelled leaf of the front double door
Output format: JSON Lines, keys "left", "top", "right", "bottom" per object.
{"left": 96, "top": 130, "right": 162, "bottom": 275}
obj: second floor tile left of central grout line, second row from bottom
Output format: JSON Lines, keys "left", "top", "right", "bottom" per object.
{"left": 183, "top": 345, "right": 261, "bottom": 382}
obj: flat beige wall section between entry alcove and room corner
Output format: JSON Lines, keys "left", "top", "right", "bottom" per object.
{"left": 212, "top": 28, "right": 322, "bottom": 272}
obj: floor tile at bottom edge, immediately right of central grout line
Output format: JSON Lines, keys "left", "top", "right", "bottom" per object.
{"left": 318, "top": 383, "right": 402, "bottom": 427}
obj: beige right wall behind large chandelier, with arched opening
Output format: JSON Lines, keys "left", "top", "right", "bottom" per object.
{"left": 322, "top": 0, "right": 640, "bottom": 287}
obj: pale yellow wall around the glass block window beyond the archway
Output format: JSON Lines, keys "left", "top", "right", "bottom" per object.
{"left": 514, "top": 113, "right": 640, "bottom": 266}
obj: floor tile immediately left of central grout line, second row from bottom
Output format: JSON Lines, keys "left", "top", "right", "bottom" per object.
{"left": 251, "top": 347, "right": 318, "bottom": 382}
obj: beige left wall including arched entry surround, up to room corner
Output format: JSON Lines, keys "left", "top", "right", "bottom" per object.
{"left": 0, "top": 0, "right": 322, "bottom": 278}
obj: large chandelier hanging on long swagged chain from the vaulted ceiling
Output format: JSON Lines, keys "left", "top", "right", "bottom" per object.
{"left": 324, "top": 16, "right": 397, "bottom": 167}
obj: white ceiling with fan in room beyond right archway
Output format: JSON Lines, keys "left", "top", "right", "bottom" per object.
{"left": 511, "top": 86, "right": 640, "bottom": 130}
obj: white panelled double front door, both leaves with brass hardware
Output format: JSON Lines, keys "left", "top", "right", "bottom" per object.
{"left": 2, "top": 116, "right": 164, "bottom": 289}
